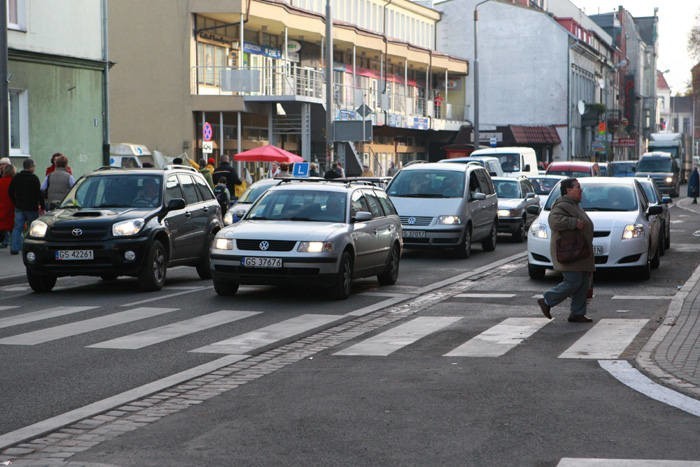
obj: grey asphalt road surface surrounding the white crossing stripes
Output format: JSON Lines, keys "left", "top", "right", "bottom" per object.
{"left": 0, "top": 202, "right": 700, "bottom": 465}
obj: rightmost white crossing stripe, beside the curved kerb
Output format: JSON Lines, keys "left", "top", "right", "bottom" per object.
{"left": 559, "top": 319, "right": 649, "bottom": 360}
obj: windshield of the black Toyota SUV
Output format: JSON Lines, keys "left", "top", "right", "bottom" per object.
{"left": 60, "top": 174, "right": 163, "bottom": 208}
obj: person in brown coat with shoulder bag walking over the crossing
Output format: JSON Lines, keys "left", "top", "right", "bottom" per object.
{"left": 537, "top": 178, "right": 595, "bottom": 323}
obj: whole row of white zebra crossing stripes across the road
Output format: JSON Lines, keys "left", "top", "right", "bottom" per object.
{"left": 0, "top": 306, "right": 649, "bottom": 360}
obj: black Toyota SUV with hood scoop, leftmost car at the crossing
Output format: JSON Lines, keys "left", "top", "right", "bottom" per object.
{"left": 22, "top": 166, "right": 223, "bottom": 292}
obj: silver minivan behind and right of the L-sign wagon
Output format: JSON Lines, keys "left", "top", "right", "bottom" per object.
{"left": 387, "top": 162, "right": 498, "bottom": 258}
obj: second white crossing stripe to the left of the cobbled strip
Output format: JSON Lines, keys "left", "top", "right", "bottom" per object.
{"left": 88, "top": 310, "right": 261, "bottom": 350}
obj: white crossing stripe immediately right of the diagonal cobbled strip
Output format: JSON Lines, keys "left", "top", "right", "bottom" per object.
{"left": 333, "top": 316, "right": 462, "bottom": 357}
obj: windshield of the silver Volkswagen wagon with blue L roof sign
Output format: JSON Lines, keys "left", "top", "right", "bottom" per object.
{"left": 245, "top": 190, "right": 347, "bottom": 222}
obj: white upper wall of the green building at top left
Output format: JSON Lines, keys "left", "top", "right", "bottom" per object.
{"left": 7, "top": 0, "right": 102, "bottom": 60}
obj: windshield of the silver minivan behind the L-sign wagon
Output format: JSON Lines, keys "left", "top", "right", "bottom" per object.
{"left": 387, "top": 170, "right": 464, "bottom": 198}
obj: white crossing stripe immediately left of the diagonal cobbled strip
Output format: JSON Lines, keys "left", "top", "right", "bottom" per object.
{"left": 190, "top": 314, "right": 345, "bottom": 355}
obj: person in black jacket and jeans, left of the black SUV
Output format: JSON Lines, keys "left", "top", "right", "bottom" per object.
{"left": 9, "top": 158, "right": 44, "bottom": 255}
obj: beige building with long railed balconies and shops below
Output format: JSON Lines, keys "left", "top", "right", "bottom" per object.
{"left": 109, "top": 0, "right": 469, "bottom": 174}
